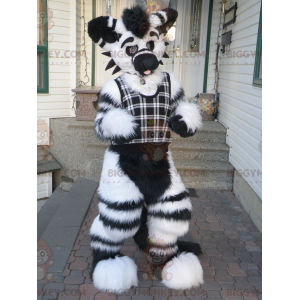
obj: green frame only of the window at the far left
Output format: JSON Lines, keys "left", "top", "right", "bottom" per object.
{"left": 37, "top": 0, "right": 49, "bottom": 94}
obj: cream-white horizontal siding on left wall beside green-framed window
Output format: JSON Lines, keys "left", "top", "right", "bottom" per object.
{"left": 37, "top": 0, "right": 81, "bottom": 199}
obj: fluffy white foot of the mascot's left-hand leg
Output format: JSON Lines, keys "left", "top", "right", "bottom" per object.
{"left": 93, "top": 256, "right": 138, "bottom": 294}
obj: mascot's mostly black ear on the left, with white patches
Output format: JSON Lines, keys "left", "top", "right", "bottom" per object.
{"left": 88, "top": 17, "right": 126, "bottom": 51}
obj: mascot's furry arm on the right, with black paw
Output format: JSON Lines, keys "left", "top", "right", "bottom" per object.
{"left": 169, "top": 73, "right": 202, "bottom": 138}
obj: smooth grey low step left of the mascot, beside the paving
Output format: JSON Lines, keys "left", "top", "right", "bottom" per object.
{"left": 37, "top": 178, "right": 98, "bottom": 276}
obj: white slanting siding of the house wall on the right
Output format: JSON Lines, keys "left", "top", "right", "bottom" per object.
{"left": 207, "top": 0, "right": 262, "bottom": 198}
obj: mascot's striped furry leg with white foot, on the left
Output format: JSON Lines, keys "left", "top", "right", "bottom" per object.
{"left": 90, "top": 150, "right": 144, "bottom": 293}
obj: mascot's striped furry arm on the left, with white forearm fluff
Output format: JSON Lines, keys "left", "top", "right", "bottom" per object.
{"left": 95, "top": 80, "right": 140, "bottom": 144}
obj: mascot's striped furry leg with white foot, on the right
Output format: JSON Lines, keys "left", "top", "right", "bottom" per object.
{"left": 147, "top": 152, "right": 203, "bottom": 289}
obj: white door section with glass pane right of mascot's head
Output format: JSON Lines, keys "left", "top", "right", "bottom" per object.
{"left": 163, "top": 0, "right": 209, "bottom": 98}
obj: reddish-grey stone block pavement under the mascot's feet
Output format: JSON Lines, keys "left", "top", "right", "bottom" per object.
{"left": 37, "top": 190, "right": 262, "bottom": 300}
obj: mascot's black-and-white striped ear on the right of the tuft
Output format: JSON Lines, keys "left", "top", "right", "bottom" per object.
{"left": 149, "top": 8, "right": 178, "bottom": 35}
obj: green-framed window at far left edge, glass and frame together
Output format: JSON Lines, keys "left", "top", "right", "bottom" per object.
{"left": 37, "top": 0, "right": 49, "bottom": 93}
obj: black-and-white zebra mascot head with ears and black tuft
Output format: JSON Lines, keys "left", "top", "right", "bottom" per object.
{"left": 88, "top": 6, "right": 178, "bottom": 76}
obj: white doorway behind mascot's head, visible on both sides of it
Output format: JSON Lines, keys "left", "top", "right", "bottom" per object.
{"left": 96, "top": 0, "right": 209, "bottom": 98}
